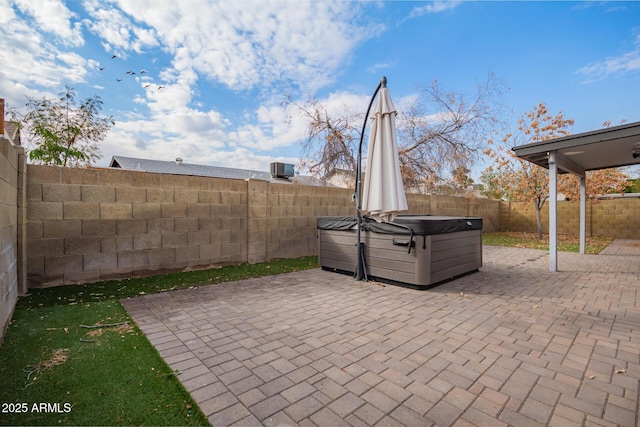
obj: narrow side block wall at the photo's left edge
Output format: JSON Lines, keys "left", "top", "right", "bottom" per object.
{"left": 0, "top": 138, "right": 26, "bottom": 343}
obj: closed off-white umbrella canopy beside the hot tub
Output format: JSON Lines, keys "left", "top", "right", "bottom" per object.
{"left": 362, "top": 87, "right": 408, "bottom": 222}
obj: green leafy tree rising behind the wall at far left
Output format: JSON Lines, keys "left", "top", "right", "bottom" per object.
{"left": 11, "top": 86, "right": 115, "bottom": 167}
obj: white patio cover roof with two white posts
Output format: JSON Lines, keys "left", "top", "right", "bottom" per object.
{"left": 513, "top": 122, "right": 640, "bottom": 271}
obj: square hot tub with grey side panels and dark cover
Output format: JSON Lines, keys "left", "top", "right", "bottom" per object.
{"left": 317, "top": 215, "right": 482, "bottom": 289}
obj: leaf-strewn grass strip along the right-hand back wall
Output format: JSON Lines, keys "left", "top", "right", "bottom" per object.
{"left": 482, "top": 231, "right": 613, "bottom": 254}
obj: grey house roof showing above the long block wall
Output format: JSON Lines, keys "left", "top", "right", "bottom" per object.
{"left": 109, "top": 156, "right": 325, "bottom": 185}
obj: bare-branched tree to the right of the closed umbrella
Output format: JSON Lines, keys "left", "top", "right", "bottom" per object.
{"left": 398, "top": 73, "right": 505, "bottom": 193}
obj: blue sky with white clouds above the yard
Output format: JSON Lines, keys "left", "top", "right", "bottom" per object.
{"left": 0, "top": 0, "right": 640, "bottom": 179}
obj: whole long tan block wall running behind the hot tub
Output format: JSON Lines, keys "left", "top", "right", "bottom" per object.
{"left": 27, "top": 165, "right": 499, "bottom": 287}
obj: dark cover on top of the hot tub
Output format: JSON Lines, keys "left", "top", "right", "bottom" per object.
{"left": 317, "top": 215, "right": 482, "bottom": 236}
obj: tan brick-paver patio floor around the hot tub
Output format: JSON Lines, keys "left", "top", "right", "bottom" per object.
{"left": 123, "top": 240, "right": 640, "bottom": 426}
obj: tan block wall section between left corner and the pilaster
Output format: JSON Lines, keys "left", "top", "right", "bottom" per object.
{"left": 27, "top": 165, "right": 248, "bottom": 287}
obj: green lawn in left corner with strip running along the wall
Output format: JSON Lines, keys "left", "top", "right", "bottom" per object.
{"left": 0, "top": 257, "right": 317, "bottom": 425}
